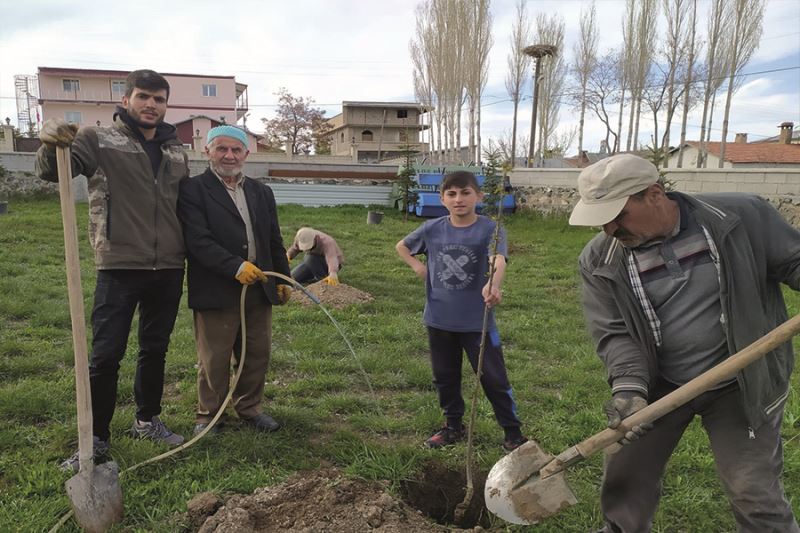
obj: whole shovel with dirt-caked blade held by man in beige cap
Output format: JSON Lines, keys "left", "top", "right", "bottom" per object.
{"left": 484, "top": 315, "right": 800, "bottom": 524}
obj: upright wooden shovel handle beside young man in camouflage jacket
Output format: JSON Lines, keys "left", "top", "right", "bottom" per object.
{"left": 56, "top": 146, "right": 94, "bottom": 472}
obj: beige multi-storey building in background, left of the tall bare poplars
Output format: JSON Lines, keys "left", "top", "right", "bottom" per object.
{"left": 326, "top": 102, "right": 428, "bottom": 162}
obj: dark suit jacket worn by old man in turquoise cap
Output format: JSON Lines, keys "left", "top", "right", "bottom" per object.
{"left": 178, "top": 169, "right": 289, "bottom": 309}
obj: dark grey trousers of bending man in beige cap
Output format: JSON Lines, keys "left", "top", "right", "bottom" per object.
{"left": 600, "top": 381, "right": 800, "bottom": 533}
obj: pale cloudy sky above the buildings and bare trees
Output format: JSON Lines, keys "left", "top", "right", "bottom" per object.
{"left": 0, "top": 0, "right": 800, "bottom": 152}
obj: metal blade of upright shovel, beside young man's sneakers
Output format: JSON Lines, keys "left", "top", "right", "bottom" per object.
{"left": 65, "top": 461, "right": 123, "bottom": 533}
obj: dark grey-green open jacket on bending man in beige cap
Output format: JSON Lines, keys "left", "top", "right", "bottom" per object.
{"left": 579, "top": 193, "right": 800, "bottom": 428}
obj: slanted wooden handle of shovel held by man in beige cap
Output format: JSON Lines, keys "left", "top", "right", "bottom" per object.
{"left": 539, "top": 315, "right": 800, "bottom": 477}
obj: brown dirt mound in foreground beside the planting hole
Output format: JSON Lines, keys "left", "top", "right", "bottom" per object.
{"left": 189, "top": 468, "right": 483, "bottom": 533}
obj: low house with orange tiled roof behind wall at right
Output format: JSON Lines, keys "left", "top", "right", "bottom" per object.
{"left": 669, "top": 122, "right": 800, "bottom": 168}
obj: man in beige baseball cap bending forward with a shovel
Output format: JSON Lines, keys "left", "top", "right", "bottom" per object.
{"left": 570, "top": 154, "right": 800, "bottom": 533}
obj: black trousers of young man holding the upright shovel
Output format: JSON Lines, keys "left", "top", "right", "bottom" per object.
{"left": 89, "top": 269, "right": 183, "bottom": 440}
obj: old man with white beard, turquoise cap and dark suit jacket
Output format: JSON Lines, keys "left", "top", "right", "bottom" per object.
{"left": 178, "top": 125, "right": 291, "bottom": 433}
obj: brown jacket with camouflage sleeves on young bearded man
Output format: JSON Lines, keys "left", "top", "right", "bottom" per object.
{"left": 36, "top": 116, "right": 189, "bottom": 270}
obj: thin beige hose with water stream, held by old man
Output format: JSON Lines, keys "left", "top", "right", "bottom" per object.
{"left": 50, "top": 270, "right": 375, "bottom": 533}
